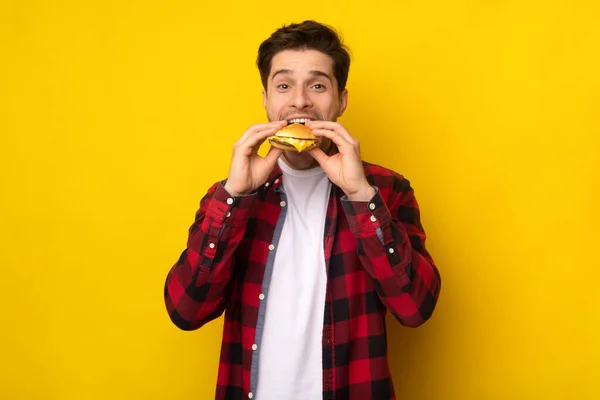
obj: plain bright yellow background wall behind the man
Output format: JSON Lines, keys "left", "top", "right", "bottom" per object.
{"left": 0, "top": 0, "right": 600, "bottom": 400}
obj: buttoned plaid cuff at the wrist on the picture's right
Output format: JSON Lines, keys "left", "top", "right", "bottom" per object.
{"left": 341, "top": 186, "right": 392, "bottom": 233}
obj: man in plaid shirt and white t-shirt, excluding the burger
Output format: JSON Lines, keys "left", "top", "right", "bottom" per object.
{"left": 165, "top": 21, "right": 441, "bottom": 400}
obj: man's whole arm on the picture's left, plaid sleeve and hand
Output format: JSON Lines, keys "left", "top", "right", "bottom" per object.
{"left": 164, "top": 121, "right": 287, "bottom": 330}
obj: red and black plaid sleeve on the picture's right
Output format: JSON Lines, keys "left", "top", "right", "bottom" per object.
{"left": 342, "top": 176, "right": 441, "bottom": 327}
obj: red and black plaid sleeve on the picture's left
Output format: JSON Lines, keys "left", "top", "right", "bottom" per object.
{"left": 164, "top": 181, "right": 256, "bottom": 330}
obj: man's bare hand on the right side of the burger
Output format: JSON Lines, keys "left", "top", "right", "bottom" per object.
{"left": 306, "top": 121, "right": 375, "bottom": 201}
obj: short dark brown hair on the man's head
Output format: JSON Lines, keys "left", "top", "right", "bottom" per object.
{"left": 256, "top": 20, "right": 350, "bottom": 94}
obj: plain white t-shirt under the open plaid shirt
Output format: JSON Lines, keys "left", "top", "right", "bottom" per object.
{"left": 255, "top": 160, "right": 331, "bottom": 400}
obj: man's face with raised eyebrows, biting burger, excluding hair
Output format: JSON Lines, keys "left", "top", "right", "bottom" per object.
{"left": 263, "top": 50, "right": 348, "bottom": 169}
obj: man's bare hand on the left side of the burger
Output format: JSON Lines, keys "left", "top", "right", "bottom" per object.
{"left": 225, "top": 121, "right": 287, "bottom": 197}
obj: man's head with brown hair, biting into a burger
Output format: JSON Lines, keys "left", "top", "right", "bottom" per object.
{"left": 256, "top": 21, "right": 350, "bottom": 169}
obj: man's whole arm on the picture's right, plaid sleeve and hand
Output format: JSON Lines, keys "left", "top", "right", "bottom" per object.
{"left": 306, "top": 121, "right": 441, "bottom": 327}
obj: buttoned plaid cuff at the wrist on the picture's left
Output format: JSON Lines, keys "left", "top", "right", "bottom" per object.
{"left": 206, "top": 181, "right": 257, "bottom": 226}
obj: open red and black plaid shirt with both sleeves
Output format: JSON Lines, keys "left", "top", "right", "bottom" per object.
{"left": 164, "top": 163, "right": 441, "bottom": 400}
